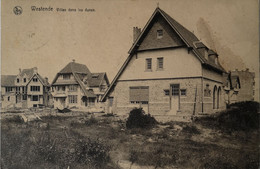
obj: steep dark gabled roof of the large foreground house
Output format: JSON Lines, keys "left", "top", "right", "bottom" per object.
{"left": 101, "top": 7, "right": 226, "bottom": 101}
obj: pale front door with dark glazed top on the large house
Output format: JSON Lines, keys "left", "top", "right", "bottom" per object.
{"left": 170, "top": 84, "right": 180, "bottom": 115}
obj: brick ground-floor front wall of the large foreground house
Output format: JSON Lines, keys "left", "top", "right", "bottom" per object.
{"left": 113, "top": 78, "right": 201, "bottom": 115}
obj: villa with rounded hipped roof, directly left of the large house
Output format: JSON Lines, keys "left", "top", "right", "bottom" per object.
{"left": 52, "top": 60, "right": 109, "bottom": 109}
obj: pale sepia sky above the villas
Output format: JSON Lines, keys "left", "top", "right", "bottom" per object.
{"left": 1, "top": 0, "right": 259, "bottom": 100}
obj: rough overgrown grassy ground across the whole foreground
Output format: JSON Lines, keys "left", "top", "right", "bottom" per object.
{"left": 1, "top": 105, "right": 259, "bottom": 169}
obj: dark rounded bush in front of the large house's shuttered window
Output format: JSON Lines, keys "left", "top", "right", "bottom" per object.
{"left": 126, "top": 108, "right": 157, "bottom": 129}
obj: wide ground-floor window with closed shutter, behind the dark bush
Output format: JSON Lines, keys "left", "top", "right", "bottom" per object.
{"left": 129, "top": 86, "right": 149, "bottom": 102}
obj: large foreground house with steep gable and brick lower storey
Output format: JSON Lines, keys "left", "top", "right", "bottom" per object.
{"left": 102, "top": 8, "right": 225, "bottom": 115}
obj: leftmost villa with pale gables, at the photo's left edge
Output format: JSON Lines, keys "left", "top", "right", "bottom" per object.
{"left": 1, "top": 67, "right": 51, "bottom": 108}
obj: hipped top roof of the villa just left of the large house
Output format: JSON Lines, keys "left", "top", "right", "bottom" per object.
{"left": 59, "top": 61, "right": 90, "bottom": 74}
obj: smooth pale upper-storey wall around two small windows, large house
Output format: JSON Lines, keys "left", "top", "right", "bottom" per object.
{"left": 119, "top": 48, "right": 202, "bottom": 80}
